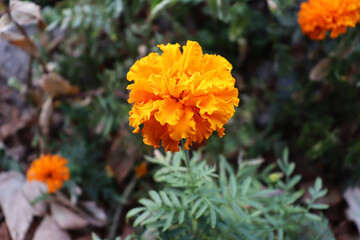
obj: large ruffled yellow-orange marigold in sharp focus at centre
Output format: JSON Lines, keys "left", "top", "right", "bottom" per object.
{"left": 127, "top": 41, "right": 239, "bottom": 152}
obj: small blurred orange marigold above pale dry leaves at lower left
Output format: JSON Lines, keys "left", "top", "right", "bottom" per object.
{"left": 27, "top": 154, "right": 70, "bottom": 193}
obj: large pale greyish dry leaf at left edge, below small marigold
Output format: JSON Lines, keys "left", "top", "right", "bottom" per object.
{"left": 0, "top": 172, "right": 45, "bottom": 240}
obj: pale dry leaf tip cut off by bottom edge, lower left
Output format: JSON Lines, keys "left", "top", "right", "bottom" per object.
{"left": 33, "top": 216, "right": 71, "bottom": 240}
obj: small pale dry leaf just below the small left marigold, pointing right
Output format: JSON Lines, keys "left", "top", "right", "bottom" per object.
{"left": 50, "top": 202, "right": 88, "bottom": 230}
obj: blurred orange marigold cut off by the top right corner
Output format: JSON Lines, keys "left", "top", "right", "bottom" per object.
{"left": 298, "top": 0, "right": 360, "bottom": 40}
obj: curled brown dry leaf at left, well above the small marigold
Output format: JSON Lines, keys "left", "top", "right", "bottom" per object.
{"left": 41, "top": 73, "right": 79, "bottom": 97}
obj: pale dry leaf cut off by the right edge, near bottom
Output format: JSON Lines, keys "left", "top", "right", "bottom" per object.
{"left": 344, "top": 187, "right": 360, "bottom": 233}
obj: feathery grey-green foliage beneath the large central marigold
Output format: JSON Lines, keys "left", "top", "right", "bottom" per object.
{"left": 127, "top": 151, "right": 333, "bottom": 239}
